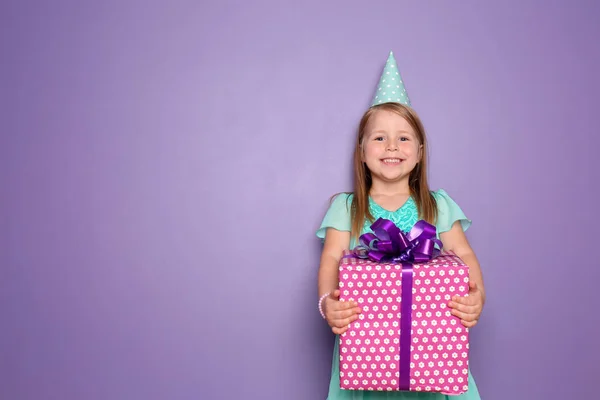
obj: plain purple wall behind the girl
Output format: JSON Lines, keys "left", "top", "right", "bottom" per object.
{"left": 0, "top": 1, "right": 600, "bottom": 400}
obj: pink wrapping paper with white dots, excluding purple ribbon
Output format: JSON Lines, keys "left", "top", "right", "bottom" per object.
{"left": 339, "top": 252, "right": 469, "bottom": 395}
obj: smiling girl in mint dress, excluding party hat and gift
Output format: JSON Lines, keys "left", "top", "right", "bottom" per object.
{"left": 317, "top": 102, "right": 485, "bottom": 400}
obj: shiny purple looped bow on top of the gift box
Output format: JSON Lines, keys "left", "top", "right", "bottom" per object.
{"left": 354, "top": 218, "right": 443, "bottom": 263}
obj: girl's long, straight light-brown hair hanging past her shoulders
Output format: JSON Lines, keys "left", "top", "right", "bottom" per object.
{"left": 351, "top": 103, "right": 437, "bottom": 239}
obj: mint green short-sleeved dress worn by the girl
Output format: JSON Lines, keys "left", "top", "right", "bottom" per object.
{"left": 317, "top": 189, "right": 481, "bottom": 400}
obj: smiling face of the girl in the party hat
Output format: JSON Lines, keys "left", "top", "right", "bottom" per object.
{"left": 362, "top": 110, "right": 423, "bottom": 182}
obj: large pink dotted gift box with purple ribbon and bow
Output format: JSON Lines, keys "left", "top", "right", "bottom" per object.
{"left": 339, "top": 219, "right": 469, "bottom": 395}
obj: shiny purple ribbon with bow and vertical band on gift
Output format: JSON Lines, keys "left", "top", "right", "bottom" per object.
{"left": 352, "top": 218, "right": 443, "bottom": 390}
